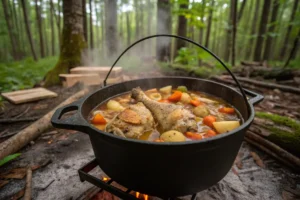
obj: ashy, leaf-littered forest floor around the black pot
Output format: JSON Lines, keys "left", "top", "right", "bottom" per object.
{"left": 0, "top": 67, "right": 300, "bottom": 200}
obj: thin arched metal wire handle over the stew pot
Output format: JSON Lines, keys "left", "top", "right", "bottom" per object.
{"left": 103, "top": 34, "right": 250, "bottom": 113}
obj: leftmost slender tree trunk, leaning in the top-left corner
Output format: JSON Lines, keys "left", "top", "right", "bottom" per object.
{"left": 2, "top": 0, "right": 18, "bottom": 60}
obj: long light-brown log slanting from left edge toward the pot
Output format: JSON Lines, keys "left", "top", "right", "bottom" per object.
{"left": 0, "top": 88, "right": 89, "bottom": 160}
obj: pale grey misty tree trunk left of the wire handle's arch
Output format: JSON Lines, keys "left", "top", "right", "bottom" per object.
{"left": 105, "top": 0, "right": 118, "bottom": 56}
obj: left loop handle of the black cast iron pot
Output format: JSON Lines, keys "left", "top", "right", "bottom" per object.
{"left": 51, "top": 101, "right": 87, "bottom": 132}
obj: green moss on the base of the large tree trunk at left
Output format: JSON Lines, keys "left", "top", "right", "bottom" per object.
{"left": 44, "top": 27, "right": 87, "bottom": 87}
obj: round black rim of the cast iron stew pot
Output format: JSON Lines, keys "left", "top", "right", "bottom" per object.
{"left": 78, "top": 76, "right": 255, "bottom": 146}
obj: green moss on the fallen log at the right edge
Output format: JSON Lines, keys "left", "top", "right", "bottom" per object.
{"left": 256, "top": 112, "right": 300, "bottom": 156}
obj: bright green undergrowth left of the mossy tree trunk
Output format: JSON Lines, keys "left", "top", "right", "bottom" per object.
{"left": 0, "top": 57, "right": 57, "bottom": 92}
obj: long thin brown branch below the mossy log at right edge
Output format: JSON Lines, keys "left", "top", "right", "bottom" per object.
{"left": 246, "top": 131, "right": 300, "bottom": 168}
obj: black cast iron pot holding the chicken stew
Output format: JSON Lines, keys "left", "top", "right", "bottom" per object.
{"left": 52, "top": 35, "right": 263, "bottom": 197}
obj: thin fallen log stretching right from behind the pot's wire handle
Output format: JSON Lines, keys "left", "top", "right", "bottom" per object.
{"left": 222, "top": 76, "right": 300, "bottom": 94}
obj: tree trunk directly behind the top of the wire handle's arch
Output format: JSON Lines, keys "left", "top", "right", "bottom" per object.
{"left": 156, "top": 0, "right": 172, "bottom": 61}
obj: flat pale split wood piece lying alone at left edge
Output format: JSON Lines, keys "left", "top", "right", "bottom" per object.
{"left": 2, "top": 88, "right": 57, "bottom": 104}
